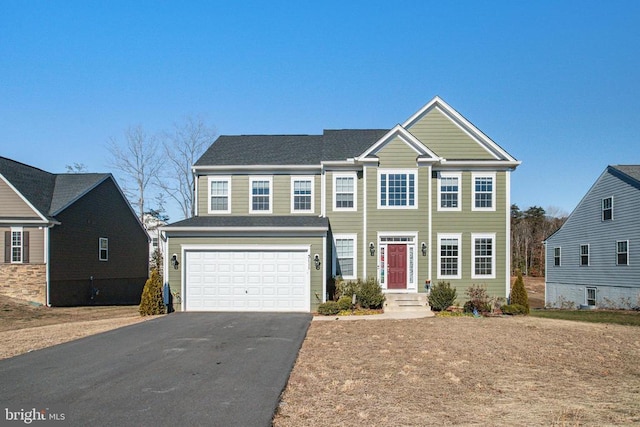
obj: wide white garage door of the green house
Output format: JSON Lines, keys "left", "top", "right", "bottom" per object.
{"left": 184, "top": 249, "right": 311, "bottom": 312}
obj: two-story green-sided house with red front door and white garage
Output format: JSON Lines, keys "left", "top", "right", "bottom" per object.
{"left": 162, "top": 97, "right": 520, "bottom": 312}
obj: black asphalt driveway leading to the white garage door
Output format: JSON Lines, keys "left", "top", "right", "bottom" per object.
{"left": 0, "top": 313, "right": 311, "bottom": 426}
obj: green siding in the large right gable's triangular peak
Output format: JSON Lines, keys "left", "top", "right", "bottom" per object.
{"left": 407, "top": 108, "right": 495, "bottom": 160}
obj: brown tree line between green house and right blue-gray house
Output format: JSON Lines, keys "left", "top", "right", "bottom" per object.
{"left": 511, "top": 204, "right": 567, "bottom": 277}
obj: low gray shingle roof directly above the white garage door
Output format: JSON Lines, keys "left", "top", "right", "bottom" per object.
{"left": 168, "top": 215, "right": 329, "bottom": 229}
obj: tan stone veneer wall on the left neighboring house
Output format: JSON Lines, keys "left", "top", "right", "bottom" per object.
{"left": 0, "top": 264, "right": 47, "bottom": 304}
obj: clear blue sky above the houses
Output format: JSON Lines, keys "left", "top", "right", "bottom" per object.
{"left": 0, "top": 0, "right": 640, "bottom": 220}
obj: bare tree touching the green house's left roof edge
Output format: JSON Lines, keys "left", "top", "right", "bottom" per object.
{"left": 156, "top": 117, "right": 216, "bottom": 218}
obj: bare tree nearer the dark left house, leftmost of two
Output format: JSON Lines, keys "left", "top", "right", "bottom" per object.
{"left": 107, "top": 126, "right": 162, "bottom": 221}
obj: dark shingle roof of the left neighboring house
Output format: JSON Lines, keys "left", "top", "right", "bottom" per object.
{"left": 0, "top": 157, "right": 111, "bottom": 218}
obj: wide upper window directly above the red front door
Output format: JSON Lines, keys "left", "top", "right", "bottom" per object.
{"left": 378, "top": 171, "right": 417, "bottom": 208}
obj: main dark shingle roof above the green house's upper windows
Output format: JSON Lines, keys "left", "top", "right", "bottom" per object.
{"left": 194, "top": 129, "right": 388, "bottom": 166}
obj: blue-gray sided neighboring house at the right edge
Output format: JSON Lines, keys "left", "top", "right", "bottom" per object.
{"left": 545, "top": 165, "right": 640, "bottom": 308}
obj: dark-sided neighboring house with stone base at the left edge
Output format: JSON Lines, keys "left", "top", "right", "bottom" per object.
{"left": 0, "top": 157, "right": 149, "bottom": 306}
